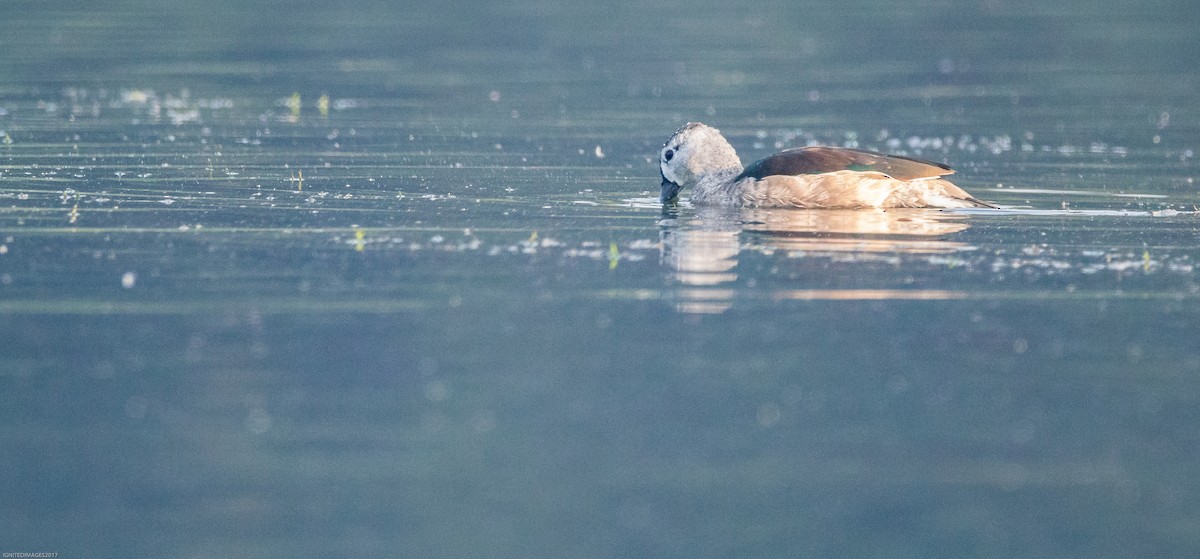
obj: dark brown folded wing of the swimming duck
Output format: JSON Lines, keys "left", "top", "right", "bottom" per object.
{"left": 737, "top": 146, "right": 954, "bottom": 180}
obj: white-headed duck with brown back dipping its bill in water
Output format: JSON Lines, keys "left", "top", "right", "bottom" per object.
{"left": 659, "top": 122, "right": 997, "bottom": 209}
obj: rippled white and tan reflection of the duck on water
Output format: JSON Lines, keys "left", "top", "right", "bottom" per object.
{"left": 660, "top": 206, "right": 973, "bottom": 313}
